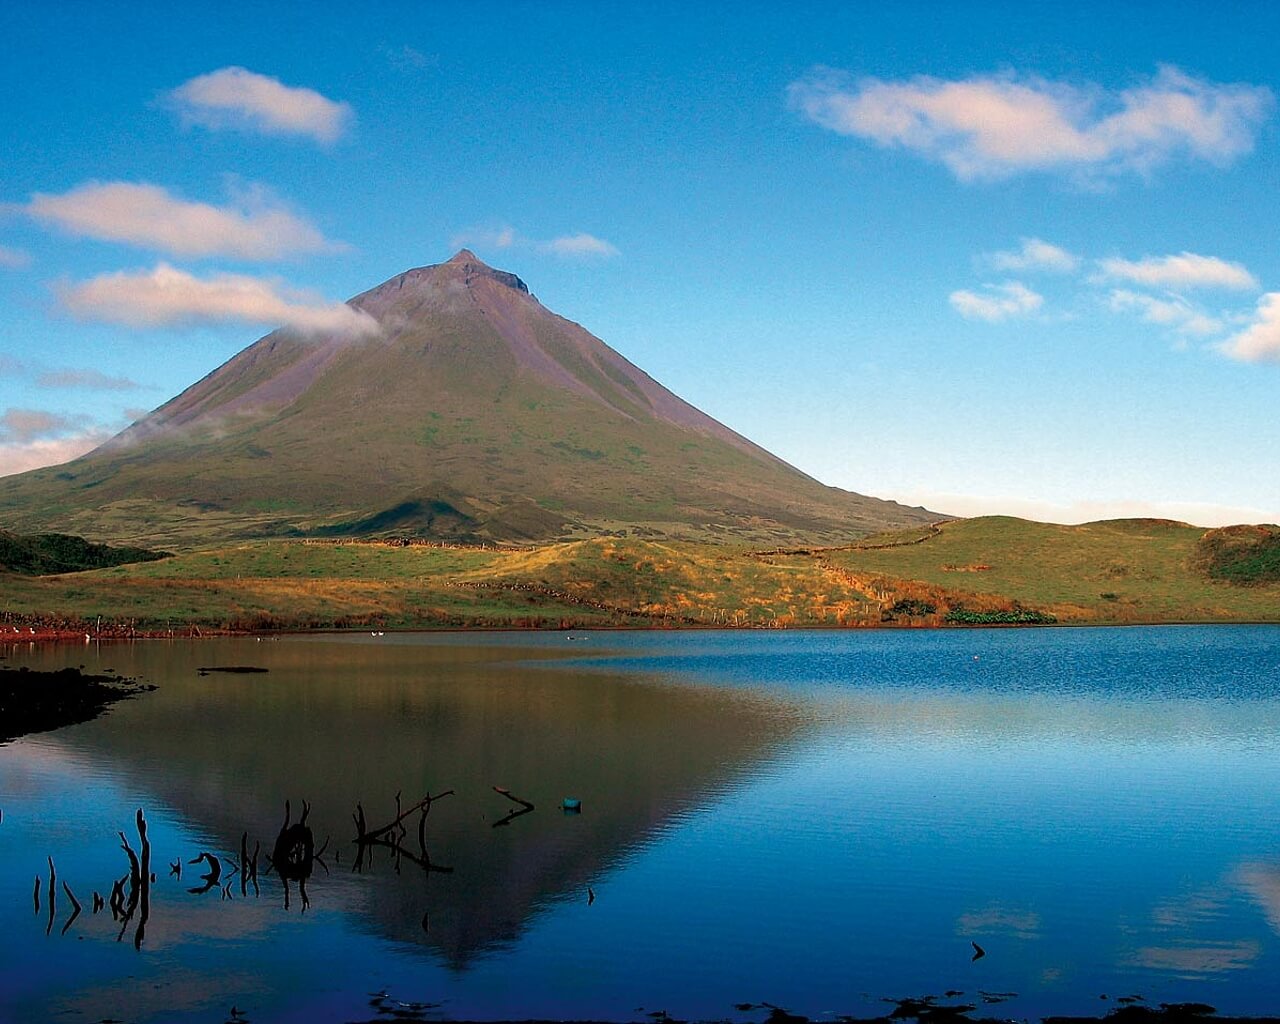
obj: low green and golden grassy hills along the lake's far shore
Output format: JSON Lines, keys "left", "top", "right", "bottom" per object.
{"left": 0, "top": 517, "right": 1280, "bottom": 630}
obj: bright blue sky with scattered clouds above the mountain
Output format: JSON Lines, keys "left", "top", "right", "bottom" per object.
{"left": 0, "top": 3, "right": 1280, "bottom": 525}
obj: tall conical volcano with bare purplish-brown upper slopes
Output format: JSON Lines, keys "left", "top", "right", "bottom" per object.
{"left": 0, "top": 250, "right": 936, "bottom": 543}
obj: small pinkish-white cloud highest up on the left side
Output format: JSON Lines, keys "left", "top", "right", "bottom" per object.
{"left": 166, "top": 68, "right": 353, "bottom": 142}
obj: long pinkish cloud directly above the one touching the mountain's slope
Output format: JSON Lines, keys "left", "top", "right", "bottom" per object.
{"left": 22, "top": 182, "right": 342, "bottom": 260}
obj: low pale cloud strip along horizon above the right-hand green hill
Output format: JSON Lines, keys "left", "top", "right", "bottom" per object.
{"left": 896, "top": 490, "right": 1280, "bottom": 526}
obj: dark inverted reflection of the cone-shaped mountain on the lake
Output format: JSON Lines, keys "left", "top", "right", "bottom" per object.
{"left": 2, "top": 640, "right": 797, "bottom": 968}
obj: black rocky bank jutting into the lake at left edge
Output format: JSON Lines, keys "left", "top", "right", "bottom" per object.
{"left": 0, "top": 668, "right": 155, "bottom": 742}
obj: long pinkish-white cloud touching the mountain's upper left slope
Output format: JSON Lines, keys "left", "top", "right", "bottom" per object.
{"left": 60, "top": 264, "right": 379, "bottom": 338}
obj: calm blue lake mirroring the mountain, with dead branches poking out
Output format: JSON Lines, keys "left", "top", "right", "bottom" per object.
{"left": 0, "top": 626, "right": 1280, "bottom": 1024}
